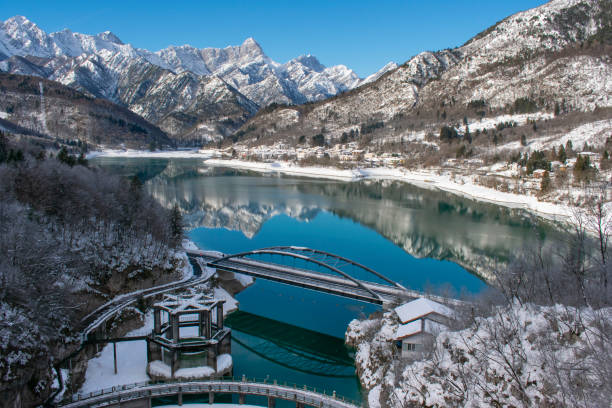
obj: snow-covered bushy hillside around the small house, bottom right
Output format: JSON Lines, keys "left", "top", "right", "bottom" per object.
{"left": 346, "top": 302, "right": 612, "bottom": 407}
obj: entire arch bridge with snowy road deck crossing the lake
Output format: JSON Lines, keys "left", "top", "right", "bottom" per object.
{"left": 188, "top": 246, "right": 448, "bottom": 305}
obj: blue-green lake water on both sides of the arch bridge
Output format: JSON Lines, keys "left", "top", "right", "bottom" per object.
{"left": 93, "top": 158, "right": 557, "bottom": 404}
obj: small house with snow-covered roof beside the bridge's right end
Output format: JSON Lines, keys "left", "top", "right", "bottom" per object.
{"left": 394, "top": 298, "right": 455, "bottom": 357}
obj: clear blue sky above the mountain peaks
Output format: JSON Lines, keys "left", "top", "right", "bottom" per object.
{"left": 0, "top": 0, "right": 545, "bottom": 77}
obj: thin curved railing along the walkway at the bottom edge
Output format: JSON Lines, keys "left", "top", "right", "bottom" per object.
{"left": 59, "top": 376, "right": 361, "bottom": 407}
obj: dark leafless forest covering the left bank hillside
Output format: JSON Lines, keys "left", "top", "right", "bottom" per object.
{"left": 0, "top": 134, "right": 181, "bottom": 405}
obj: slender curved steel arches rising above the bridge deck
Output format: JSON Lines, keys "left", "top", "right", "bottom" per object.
{"left": 209, "top": 246, "right": 406, "bottom": 301}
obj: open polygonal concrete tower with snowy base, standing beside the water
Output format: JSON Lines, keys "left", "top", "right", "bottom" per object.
{"left": 147, "top": 294, "right": 233, "bottom": 381}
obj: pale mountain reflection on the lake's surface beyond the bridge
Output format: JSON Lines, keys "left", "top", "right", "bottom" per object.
{"left": 94, "top": 158, "right": 558, "bottom": 278}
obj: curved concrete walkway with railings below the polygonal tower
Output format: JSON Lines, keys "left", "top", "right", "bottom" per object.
{"left": 61, "top": 379, "right": 359, "bottom": 408}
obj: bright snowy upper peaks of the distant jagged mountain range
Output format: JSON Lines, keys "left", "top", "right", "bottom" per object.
{"left": 0, "top": 16, "right": 368, "bottom": 106}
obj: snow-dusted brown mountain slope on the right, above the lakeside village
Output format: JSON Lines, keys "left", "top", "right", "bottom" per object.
{"left": 233, "top": 0, "right": 612, "bottom": 147}
